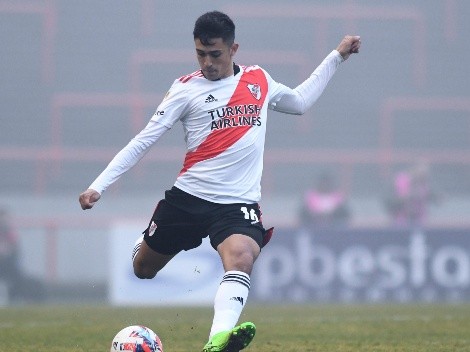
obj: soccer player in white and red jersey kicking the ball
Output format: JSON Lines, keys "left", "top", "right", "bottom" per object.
{"left": 79, "top": 11, "right": 361, "bottom": 352}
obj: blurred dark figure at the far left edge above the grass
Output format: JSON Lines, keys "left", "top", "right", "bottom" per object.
{"left": 0, "top": 208, "right": 44, "bottom": 303}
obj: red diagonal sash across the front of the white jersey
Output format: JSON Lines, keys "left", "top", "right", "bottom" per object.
{"left": 178, "top": 69, "right": 268, "bottom": 176}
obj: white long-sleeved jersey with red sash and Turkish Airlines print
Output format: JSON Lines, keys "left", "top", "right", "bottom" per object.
{"left": 90, "top": 51, "right": 342, "bottom": 204}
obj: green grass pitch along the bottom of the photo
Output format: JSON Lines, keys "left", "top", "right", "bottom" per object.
{"left": 0, "top": 304, "right": 470, "bottom": 352}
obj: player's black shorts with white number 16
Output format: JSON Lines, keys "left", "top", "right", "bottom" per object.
{"left": 143, "top": 187, "right": 272, "bottom": 255}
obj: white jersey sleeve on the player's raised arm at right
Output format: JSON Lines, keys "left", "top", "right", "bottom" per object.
{"left": 269, "top": 50, "right": 344, "bottom": 115}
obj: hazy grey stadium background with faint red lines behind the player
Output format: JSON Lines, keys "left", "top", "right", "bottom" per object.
{"left": 0, "top": 0, "right": 470, "bottom": 304}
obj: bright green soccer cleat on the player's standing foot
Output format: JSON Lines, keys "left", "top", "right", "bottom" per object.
{"left": 202, "top": 322, "right": 256, "bottom": 352}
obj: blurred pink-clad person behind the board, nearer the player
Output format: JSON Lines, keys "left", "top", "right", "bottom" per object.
{"left": 300, "top": 173, "right": 350, "bottom": 228}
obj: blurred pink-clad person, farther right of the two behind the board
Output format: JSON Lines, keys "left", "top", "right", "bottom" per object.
{"left": 386, "top": 162, "right": 439, "bottom": 226}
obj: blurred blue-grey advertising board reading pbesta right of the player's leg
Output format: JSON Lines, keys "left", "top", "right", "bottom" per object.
{"left": 250, "top": 229, "right": 470, "bottom": 302}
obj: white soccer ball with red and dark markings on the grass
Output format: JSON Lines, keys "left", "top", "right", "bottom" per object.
{"left": 110, "top": 325, "right": 163, "bottom": 352}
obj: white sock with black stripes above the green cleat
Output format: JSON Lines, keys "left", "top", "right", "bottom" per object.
{"left": 209, "top": 270, "right": 250, "bottom": 339}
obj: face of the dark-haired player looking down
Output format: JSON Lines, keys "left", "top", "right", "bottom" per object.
{"left": 194, "top": 38, "right": 238, "bottom": 81}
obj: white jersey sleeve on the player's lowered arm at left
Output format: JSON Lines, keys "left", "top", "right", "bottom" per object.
{"left": 89, "top": 120, "right": 169, "bottom": 194}
